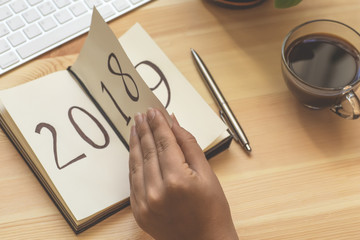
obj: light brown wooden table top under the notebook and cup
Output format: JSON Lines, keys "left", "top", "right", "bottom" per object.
{"left": 0, "top": 0, "right": 360, "bottom": 240}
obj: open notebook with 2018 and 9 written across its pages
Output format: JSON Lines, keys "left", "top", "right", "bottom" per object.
{"left": 0, "top": 9, "right": 232, "bottom": 233}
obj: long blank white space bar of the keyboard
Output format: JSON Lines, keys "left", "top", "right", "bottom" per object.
{"left": 17, "top": 14, "right": 91, "bottom": 59}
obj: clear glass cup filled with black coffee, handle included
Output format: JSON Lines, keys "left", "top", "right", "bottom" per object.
{"left": 281, "top": 19, "right": 360, "bottom": 119}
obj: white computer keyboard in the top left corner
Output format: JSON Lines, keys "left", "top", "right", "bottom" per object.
{"left": 0, "top": 0, "right": 151, "bottom": 75}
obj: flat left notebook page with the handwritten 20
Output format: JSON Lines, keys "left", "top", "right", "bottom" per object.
{"left": 0, "top": 71, "right": 130, "bottom": 220}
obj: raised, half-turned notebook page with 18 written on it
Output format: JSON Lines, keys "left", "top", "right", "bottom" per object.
{"left": 70, "top": 8, "right": 171, "bottom": 144}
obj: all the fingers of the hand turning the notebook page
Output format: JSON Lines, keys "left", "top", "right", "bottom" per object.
{"left": 129, "top": 109, "right": 205, "bottom": 208}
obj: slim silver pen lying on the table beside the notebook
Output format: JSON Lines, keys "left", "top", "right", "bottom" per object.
{"left": 191, "top": 49, "right": 251, "bottom": 152}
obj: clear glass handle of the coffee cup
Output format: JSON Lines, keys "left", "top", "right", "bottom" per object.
{"left": 331, "top": 91, "right": 360, "bottom": 119}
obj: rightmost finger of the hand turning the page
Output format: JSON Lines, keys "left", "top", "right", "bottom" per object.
{"left": 171, "top": 115, "right": 209, "bottom": 172}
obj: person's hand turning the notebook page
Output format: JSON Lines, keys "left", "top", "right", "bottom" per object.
{"left": 129, "top": 109, "right": 238, "bottom": 240}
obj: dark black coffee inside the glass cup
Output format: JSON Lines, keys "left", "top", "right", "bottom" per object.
{"left": 286, "top": 34, "right": 359, "bottom": 88}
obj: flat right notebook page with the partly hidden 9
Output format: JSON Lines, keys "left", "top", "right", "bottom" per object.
{"left": 119, "top": 24, "right": 227, "bottom": 149}
